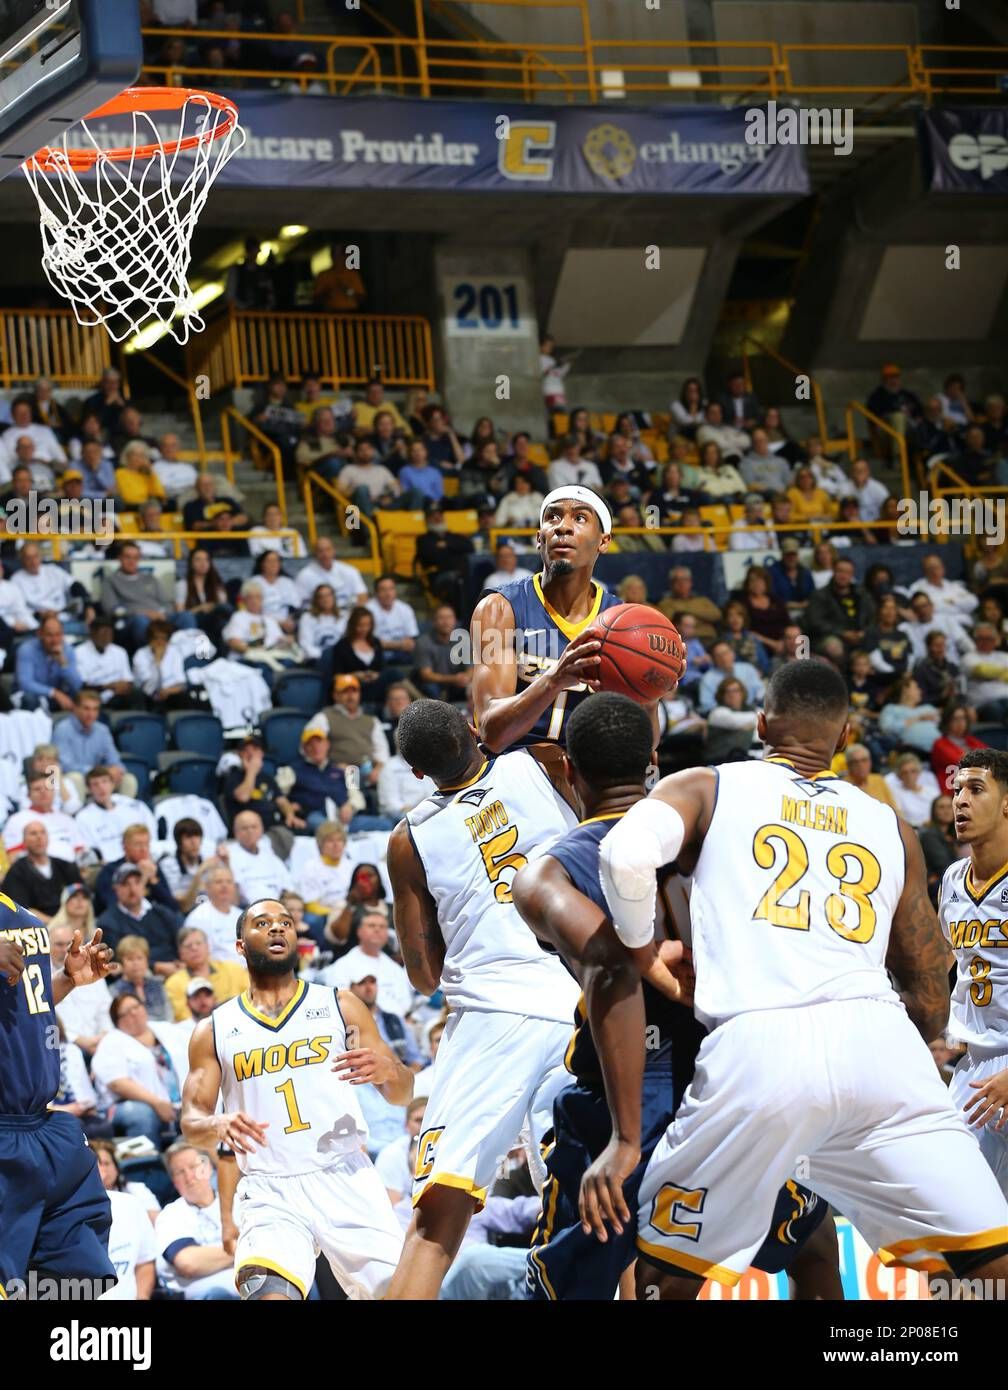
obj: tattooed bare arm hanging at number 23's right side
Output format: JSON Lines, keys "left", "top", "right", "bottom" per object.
{"left": 886, "top": 820, "right": 948, "bottom": 1043}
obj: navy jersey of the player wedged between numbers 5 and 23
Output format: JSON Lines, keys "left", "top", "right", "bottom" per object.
{"left": 548, "top": 812, "right": 706, "bottom": 1094}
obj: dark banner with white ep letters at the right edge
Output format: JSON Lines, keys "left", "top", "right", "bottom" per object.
{"left": 918, "top": 106, "right": 1008, "bottom": 196}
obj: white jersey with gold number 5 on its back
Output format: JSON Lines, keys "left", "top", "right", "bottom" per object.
{"left": 406, "top": 749, "right": 578, "bottom": 1022}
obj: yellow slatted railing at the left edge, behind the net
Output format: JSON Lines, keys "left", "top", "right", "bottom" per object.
{"left": 0, "top": 309, "right": 113, "bottom": 391}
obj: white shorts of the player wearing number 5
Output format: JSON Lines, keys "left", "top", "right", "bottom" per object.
{"left": 413, "top": 1009, "right": 570, "bottom": 1207}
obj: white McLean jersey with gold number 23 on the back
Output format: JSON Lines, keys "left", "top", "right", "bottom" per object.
{"left": 690, "top": 758, "right": 904, "bottom": 1027}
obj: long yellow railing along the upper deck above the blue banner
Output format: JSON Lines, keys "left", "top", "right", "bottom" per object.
{"left": 145, "top": 17, "right": 1008, "bottom": 103}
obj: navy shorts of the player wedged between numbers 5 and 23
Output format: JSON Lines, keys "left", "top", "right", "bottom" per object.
{"left": 526, "top": 1044, "right": 829, "bottom": 1301}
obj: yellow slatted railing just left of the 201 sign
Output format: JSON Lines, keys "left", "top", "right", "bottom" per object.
{"left": 188, "top": 309, "right": 434, "bottom": 392}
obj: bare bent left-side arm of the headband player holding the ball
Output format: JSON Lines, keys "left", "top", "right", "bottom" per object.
{"left": 470, "top": 594, "right": 601, "bottom": 752}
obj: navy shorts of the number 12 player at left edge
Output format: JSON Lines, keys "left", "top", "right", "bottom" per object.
{"left": 0, "top": 1111, "right": 115, "bottom": 1298}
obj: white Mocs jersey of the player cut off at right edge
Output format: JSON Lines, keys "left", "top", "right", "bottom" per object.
{"left": 938, "top": 859, "right": 1008, "bottom": 1058}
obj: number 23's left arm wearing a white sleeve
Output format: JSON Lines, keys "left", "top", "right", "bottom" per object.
{"left": 599, "top": 767, "right": 717, "bottom": 948}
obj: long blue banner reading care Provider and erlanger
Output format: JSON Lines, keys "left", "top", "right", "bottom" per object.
{"left": 76, "top": 92, "right": 809, "bottom": 195}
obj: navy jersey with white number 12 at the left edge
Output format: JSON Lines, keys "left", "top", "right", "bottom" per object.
{"left": 0, "top": 894, "right": 60, "bottom": 1115}
